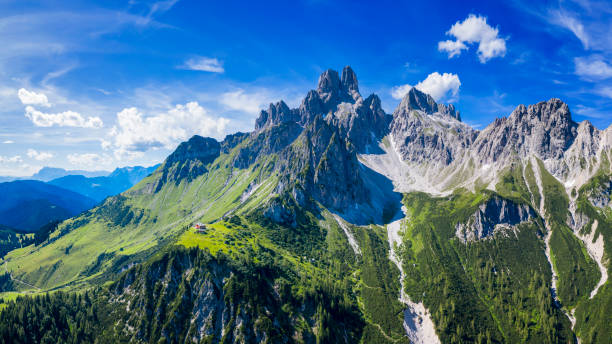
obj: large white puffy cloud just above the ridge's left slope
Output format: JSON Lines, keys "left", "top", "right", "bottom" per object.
{"left": 102, "top": 102, "right": 229, "bottom": 157}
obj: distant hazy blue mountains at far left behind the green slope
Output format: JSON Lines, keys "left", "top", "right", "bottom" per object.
{"left": 0, "top": 165, "right": 158, "bottom": 232}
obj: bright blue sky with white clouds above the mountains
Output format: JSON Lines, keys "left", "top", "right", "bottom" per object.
{"left": 0, "top": 0, "right": 612, "bottom": 175}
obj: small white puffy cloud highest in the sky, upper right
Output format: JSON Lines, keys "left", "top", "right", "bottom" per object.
{"left": 438, "top": 14, "right": 506, "bottom": 63}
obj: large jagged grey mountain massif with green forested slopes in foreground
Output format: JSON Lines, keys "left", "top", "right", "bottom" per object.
{"left": 0, "top": 67, "right": 612, "bottom": 343}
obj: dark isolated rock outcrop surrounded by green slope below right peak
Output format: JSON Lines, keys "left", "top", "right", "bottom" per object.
{"left": 455, "top": 196, "right": 536, "bottom": 243}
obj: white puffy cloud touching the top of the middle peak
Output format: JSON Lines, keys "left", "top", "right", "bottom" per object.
{"left": 391, "top": 72, "right": 461, "bottom": 102}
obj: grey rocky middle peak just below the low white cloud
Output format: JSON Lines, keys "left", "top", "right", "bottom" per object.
{"left": 390, "top": 88, "right": 477, "bottom": 165}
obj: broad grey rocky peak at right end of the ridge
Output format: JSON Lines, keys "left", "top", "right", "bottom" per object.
{"left": 474, "top": 98, "right": 578, "bottom": 163}
